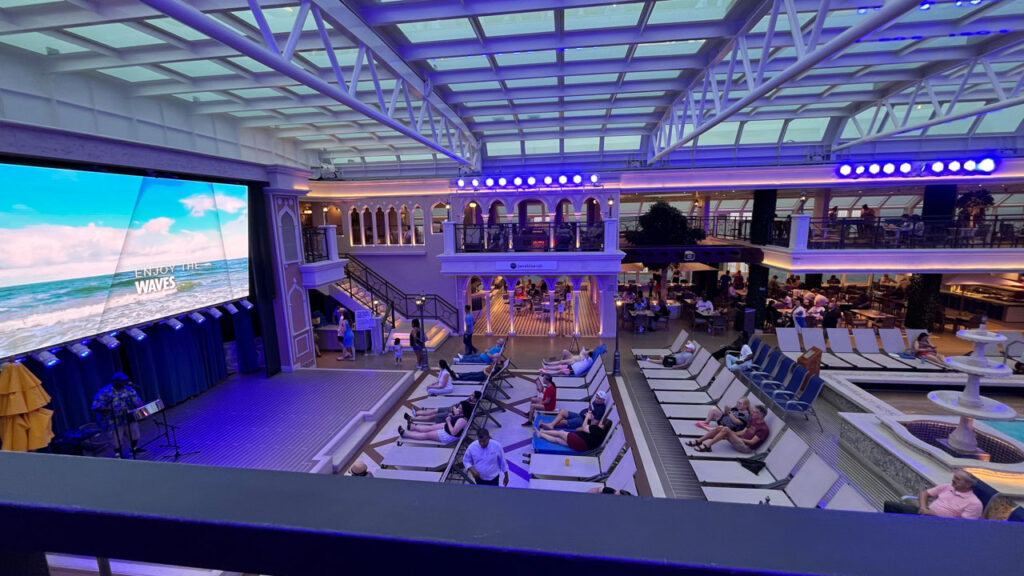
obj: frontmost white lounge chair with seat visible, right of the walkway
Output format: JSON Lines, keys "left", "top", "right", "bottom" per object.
{"left": 702, "top": 453, "right": 839, "bottom": 508}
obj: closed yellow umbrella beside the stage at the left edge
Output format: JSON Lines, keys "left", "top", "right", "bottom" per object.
{"left": 0, "top": 362, "right": 53, "bottom": 452}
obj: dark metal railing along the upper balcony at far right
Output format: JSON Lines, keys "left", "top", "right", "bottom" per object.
{"left": 807, "top": 216, "right": 1024, "bottom": 250}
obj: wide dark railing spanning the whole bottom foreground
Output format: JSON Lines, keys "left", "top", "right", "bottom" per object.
{"left": 0, "top": 452, "right": 1024, "bottom": 576}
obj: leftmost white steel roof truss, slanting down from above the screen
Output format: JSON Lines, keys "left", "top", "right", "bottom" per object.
{"left": 142, "top": 0, "right": 479, "bottom": 166}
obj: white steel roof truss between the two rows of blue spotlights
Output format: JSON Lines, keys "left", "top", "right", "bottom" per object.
{"left": 648, "top": 0, "right": 921, "bottom": 163}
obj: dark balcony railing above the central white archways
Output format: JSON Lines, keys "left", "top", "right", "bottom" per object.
{"left": 455, "top": 222, "right": 604, "bottom": 252}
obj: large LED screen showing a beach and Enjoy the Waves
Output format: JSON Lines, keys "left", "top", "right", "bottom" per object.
{"left": 0, "top": 164, "right": 249, "bottom": 358}
